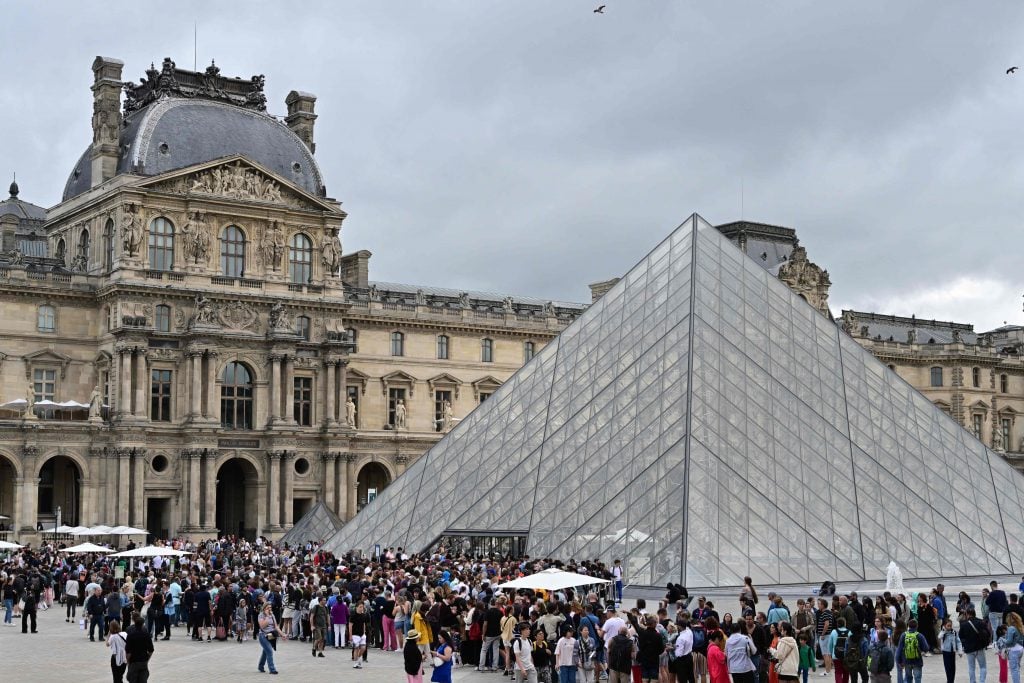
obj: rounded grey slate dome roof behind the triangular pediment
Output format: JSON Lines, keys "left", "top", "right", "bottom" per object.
{"left": 63, "top": 97, "right": 327, "bottom": 201}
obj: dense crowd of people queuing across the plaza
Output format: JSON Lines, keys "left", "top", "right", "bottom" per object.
{"left": 0, "top": 538, "right": 1024, "bottom": 683}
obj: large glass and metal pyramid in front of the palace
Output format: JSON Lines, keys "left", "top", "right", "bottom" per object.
{"left": 328, "top": 214, "right": 1024, "bottom": 587}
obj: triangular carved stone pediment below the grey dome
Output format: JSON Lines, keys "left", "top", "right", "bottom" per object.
{"left": 141, "top": 157, "right": 337, "bottom": 212}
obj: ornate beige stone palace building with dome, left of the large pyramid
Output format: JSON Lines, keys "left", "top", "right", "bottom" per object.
{"left": 0, "top": 57, "right": 585, "bottom": 543}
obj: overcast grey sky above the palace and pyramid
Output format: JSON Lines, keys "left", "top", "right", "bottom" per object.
{"left": 0, "top": 0, "right": 1024, "bottom": 329}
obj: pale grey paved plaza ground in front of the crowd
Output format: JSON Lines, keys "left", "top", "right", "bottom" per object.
{"left": 0, "top": 607, "right": 974, "bottom": 683}
